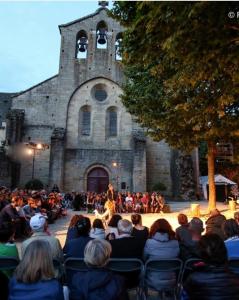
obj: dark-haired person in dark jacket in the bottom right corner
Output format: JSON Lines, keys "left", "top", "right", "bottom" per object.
{"left": 184, "top": 234, "right": 239, "bottom": 300}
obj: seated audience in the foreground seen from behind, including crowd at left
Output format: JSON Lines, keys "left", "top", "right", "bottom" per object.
{"left": 0, "top": 184, "right": 239, "bottom": 300}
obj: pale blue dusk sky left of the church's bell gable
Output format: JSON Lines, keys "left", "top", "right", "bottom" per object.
{"left": 0, "top": 0, "right": 112, "bottom": 92}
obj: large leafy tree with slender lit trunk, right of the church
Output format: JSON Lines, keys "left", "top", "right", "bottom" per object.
{"left": 111, "top": 1, "right": 239, "bottom": 209}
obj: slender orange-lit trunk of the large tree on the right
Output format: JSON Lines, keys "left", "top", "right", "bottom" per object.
{"left": 207, "top": 142, "right": 216, "bottom": 211}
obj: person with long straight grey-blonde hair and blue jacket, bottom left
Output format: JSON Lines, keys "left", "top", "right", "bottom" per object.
{"left": 8, "top": 240, "right": 64, "bottom": 300}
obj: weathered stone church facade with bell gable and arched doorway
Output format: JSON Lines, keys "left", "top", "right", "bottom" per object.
{"left": 7, "top": 7, "right": 194, "bottom": 196}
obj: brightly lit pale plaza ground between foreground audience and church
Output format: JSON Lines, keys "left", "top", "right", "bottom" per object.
{"left": 50, "top": 201, "right": 239, "bottom": 246}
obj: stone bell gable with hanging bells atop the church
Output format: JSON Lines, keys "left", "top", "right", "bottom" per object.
{"left": 59, "top": 1, "right": 124, "bottom": 89}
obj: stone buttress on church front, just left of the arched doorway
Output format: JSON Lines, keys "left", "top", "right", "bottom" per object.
{"left": 49, "top": 127, "right": 65, "bottom": 190}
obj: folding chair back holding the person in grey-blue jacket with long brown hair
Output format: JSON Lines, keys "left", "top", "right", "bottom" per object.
{"left": 143, "top": 258, "right": 183, "bottom": 299}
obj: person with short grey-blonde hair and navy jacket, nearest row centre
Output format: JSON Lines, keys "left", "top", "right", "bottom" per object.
{"left": 69, "top": 239, "right": 128, "bottom": 300}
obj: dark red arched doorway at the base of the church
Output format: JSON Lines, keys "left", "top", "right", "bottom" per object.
{"left": 87, "top": 167, "right": 109, "bottom": 193}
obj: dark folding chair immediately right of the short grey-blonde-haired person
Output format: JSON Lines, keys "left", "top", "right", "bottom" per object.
{"left": 106, "top": 258, "right": 144, "bottom": 299}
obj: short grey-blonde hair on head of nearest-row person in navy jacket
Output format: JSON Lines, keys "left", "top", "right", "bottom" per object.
{"left": 84, "top": 239, "right": 112, "bottom": 268}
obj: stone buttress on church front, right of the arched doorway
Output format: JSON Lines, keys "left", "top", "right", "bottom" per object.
{"left": 133, "top": 131, "right": 146, "bottom": 192}
